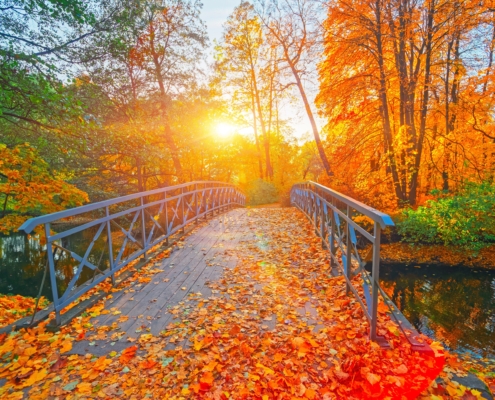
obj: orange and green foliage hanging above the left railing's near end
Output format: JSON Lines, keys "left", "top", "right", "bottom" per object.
{"left": 0, "top": 144, "right": 89, "bottom": 232}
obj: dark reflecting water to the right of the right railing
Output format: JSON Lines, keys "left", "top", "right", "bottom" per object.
{"left": 380, "top": 265, "right": 495, "bottom": 359}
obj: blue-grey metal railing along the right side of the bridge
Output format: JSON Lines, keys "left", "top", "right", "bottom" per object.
{"left": 291, "top": 182, "right": 394, "bottom": 341}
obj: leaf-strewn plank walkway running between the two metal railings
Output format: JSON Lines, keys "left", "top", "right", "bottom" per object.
{"left": 0, "top": 208, "right": 443, "bottom": 399}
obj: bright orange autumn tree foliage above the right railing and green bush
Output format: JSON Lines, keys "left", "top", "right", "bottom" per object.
{"left": 316, "top": 0, "right": 495, "bottom": 209}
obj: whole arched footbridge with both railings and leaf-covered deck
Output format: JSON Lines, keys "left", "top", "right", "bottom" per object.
{"left": 0, "top": 182, "right": 443, "bottom": 399}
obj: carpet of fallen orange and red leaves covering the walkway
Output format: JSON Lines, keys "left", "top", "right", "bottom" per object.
{"left": 0, "top": 208, "right": 460, "bottom": 400}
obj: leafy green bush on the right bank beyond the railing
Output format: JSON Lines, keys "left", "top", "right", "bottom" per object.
{"left": 397, "top": 182, "right": 495, "bottom": 251}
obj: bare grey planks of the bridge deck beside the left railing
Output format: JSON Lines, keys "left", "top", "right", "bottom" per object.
{"left": 72, "top": 208, "right": 321, "bottom": 354}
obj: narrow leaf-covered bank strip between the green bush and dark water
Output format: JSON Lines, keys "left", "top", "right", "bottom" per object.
{"left": 380, "top": 242, "right": 495, "bottom": 270}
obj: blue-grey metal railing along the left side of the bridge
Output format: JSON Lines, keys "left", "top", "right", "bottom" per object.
{"left": 19, "top": 182, "right": 246, "bottom": 325}
